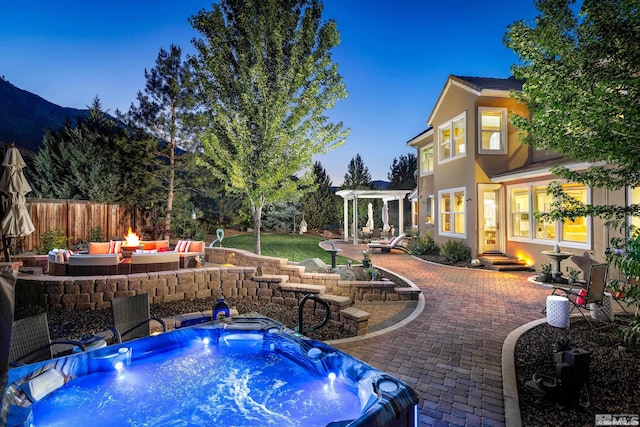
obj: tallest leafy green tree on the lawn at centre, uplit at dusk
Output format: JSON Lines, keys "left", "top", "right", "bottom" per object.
{"left": 190, "top": 0, "right": 347, "bottom": 254}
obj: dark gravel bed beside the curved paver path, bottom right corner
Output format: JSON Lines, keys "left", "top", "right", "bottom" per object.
{"left": 515, "top": 317, "right": 640, "bottom": 427}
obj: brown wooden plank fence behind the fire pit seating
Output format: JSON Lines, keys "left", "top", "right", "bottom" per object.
{"left": 20, "top": 198, "right": 147, "bottom": 251}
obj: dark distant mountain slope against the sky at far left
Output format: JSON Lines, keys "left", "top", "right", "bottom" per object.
{"left": 0, "top": 77, "right": 87, "bottom": 153}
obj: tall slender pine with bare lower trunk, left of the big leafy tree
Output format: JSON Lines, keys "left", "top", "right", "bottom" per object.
{"left": 121, "top": 45, "right": 196, "bottom": 229}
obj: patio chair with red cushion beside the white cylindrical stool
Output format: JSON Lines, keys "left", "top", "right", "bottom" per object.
{"left": 543, "top": 264, "right": 612, "bottom": 328}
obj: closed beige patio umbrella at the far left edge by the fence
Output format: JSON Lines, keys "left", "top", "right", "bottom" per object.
{"left": 0, "top": 147, "right": 35, "bottom": 249}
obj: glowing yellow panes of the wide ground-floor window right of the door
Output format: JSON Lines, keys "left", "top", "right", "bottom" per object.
{"left": 509, "top": 183, "right": 590, "bottom": 247}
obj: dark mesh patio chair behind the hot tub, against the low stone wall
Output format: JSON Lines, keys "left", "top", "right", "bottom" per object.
{"left": 109, "top": 294, "right": 167, "bottom": 343}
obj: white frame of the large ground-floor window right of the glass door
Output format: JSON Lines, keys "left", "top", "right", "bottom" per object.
{"left": 507, "top": 181, "right": 593, "bottom": 250}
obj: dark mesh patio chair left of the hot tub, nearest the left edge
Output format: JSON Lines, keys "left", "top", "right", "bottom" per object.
{"left": 9, "top": 313, "right": 87, "bottom": 367}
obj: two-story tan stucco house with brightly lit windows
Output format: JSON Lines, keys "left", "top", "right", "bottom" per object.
{"left": 407, "top": 75, "right": 640, "bottom": 272}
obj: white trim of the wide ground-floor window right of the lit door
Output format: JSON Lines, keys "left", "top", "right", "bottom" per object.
{"left": 506, "top": 181, "right": 593, "bottom": 250}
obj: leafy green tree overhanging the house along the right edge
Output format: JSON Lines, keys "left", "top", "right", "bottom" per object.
{"left": 505, "top": 0, "right": 640, "bottom": 333}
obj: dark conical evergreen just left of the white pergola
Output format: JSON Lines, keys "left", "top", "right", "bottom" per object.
{"left": 301, "top": 162, "right": 340, "bottom": 230}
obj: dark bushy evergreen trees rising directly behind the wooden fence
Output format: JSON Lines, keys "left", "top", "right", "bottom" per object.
{"left": 33, "top": 98, "right": 156, "bottom": 207}
